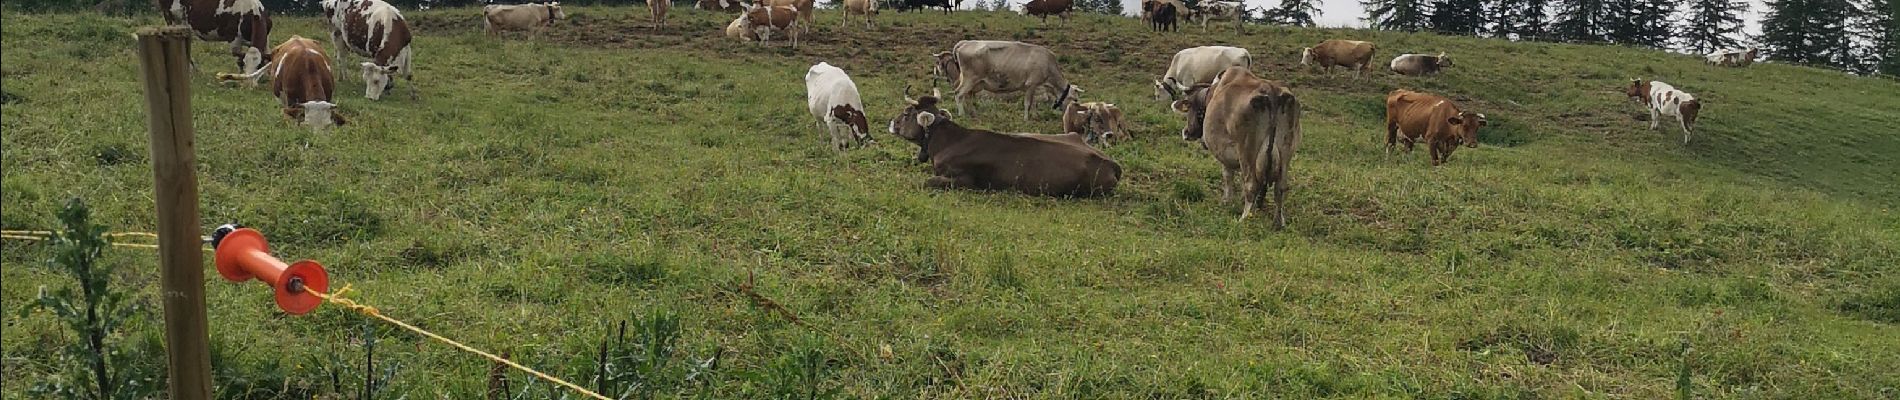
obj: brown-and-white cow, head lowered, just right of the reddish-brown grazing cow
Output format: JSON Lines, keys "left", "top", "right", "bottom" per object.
{"left": 336, "top": 0, "right": 416, "bottom": 100}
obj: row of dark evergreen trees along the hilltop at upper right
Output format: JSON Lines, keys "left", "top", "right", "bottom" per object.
{"left": 1368, "top": 0, "right": 1900, "bottom": 76}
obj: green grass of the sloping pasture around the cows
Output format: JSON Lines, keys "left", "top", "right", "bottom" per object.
{"left": 0, "top": 8, "right": 1900, "bottom": 398}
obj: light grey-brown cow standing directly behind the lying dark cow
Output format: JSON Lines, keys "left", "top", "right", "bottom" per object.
{"left": 937, "top": 40, "right": 1081, "bottom": 121}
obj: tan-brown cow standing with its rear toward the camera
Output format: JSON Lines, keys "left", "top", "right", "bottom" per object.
{"left": 1174, "top": 66, "right": 1300, "bottom": 229}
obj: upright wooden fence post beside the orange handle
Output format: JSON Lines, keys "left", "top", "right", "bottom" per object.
{"left": 139, "top": 27, "right": 211, "bottom": 400}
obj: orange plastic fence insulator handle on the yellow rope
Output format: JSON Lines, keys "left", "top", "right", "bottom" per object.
{"left": 211, "top": 226, "right": 331, "bottom": 315}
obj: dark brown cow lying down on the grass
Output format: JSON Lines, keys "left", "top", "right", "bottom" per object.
{"left": 889, "top": 87, "right": 1121, "bottom": 197}
